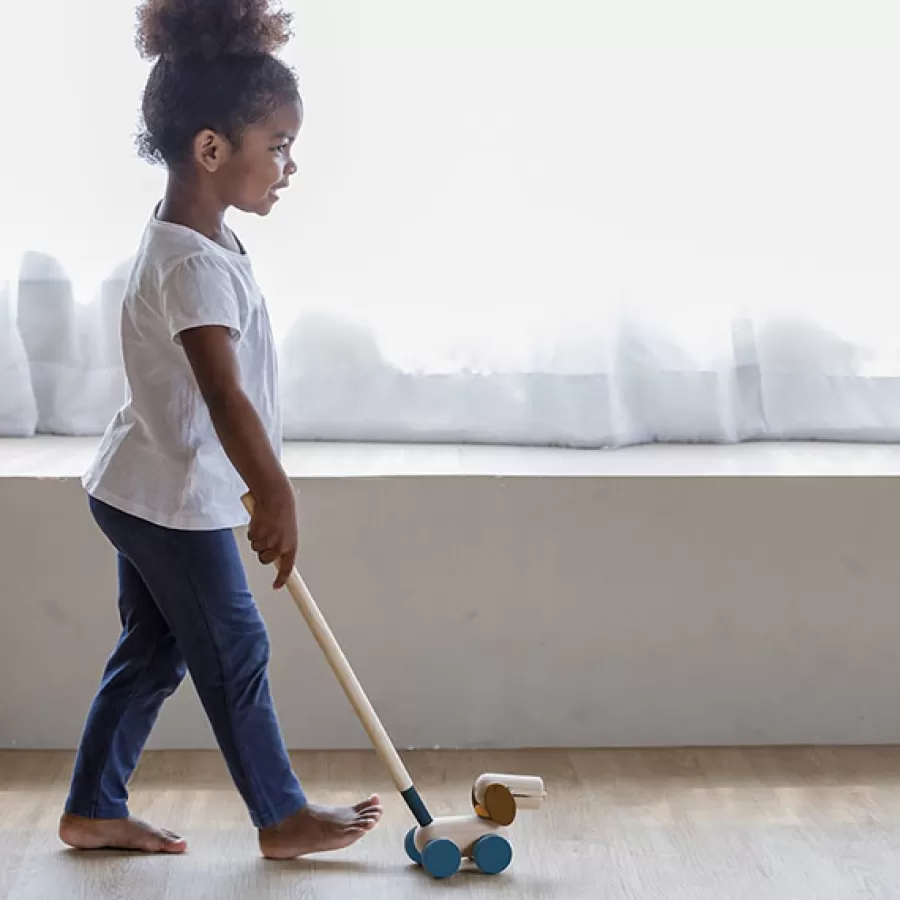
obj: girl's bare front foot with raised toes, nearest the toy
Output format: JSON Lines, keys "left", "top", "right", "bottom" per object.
{"left": 259, "top": 794, "right": 382, "bottom": 859}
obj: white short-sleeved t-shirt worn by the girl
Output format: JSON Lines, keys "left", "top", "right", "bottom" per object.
{"left": 83, "top": 216, "right": 281, "bottom": 530}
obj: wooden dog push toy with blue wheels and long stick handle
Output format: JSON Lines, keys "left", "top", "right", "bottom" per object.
{"left": 243, "top": 494, "right": 547, "bottom": 878}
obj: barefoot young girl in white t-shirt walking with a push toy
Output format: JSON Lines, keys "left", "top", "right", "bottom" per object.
{"left": 59, "top": 0, "right": 381, "bottom": 858}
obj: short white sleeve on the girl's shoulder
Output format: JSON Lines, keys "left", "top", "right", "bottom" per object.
{"left": 161, "top": 254, "right": 241, "bottom": 341}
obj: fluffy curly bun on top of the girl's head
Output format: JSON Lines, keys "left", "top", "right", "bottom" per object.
{"left": 137, "top": 0, "right": 291, "bottom": 59}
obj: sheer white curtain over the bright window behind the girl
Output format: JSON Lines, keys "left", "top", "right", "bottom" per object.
{"left": 0, "top": 0, "right": 900, "bottom": 446}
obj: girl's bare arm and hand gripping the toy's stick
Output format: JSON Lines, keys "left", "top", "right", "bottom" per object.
{"left": 180, "top": 325, "right": 297, "bottom": 588}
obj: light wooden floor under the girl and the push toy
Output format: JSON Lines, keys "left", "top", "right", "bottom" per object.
{"left": 0, "top": 748, "right": 900, "bottom": 900}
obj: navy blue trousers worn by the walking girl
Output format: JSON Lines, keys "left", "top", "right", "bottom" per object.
{"left": 66, "top": 498, "right": 306, "bottom": 828}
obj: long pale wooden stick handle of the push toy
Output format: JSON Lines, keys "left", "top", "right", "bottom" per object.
{"left": 242, "top": 494, "right": 413, "bottom": 794}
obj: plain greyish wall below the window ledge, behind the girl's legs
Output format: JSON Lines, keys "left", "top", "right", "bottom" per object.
{"left": 0, "top": 451, "right": 900, "bottom": 747}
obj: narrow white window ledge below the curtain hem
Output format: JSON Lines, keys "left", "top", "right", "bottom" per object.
{"left": 0, "top": 436, "right": 900, "bottom": 479}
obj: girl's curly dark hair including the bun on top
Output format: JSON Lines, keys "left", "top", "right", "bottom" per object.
{"left": 137, "top": 0, "right": 299, "bottom": 168}
